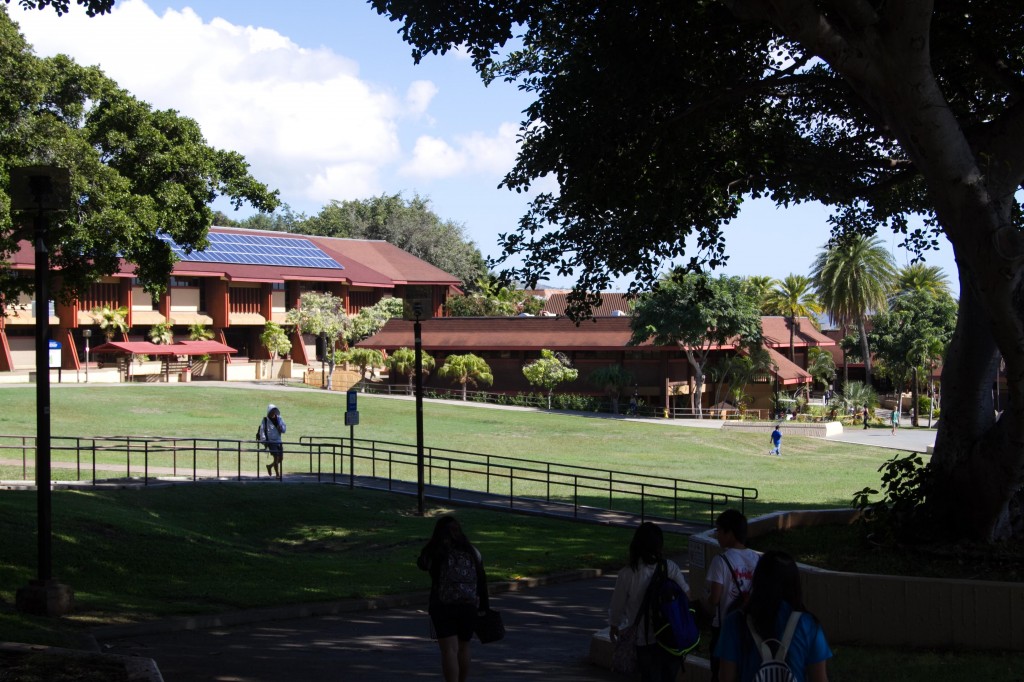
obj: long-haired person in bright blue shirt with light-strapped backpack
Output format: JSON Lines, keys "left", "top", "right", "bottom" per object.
{"left": 715, "top": 551, "right": 833, "bottom": 682}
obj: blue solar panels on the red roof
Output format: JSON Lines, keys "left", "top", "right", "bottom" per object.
{"left": 154, "top": 232, "right": 344, "bottom": 270}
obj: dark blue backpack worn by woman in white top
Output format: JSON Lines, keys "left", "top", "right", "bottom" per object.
{"left": 637, "top": 559, "right": 700, "bottom": 656}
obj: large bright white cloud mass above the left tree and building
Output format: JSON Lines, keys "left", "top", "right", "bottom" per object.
{"left": 8, "top": 0, "right": 517, "bottom": 212}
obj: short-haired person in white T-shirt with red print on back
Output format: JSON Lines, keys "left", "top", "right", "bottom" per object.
{"left": 705, "top": 509, "right": 761, "bottom": 682}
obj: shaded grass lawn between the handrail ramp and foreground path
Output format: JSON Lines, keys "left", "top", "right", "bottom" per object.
{"left": 0, "top": 483, "right": 634, "bottom": 642}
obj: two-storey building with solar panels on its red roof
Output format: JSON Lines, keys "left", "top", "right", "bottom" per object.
{"left": 0, "top": 226, "right": 460, "bottom": 372}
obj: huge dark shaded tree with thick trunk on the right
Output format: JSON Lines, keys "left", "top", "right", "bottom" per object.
{"left": 371, "top": 0, "right": 1024, "bottom": 539}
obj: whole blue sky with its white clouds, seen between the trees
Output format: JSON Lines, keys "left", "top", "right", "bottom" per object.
{"left": 6, "top": 0, "right": 959, "bottom": 292}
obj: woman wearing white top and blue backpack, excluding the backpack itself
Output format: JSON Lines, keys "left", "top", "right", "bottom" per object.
{"left": 608, "top": 521, "right": 690, "bottom": 682}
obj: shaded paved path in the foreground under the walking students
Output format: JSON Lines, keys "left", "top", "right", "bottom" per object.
{"left": 98, "top": 577, "right": 624, "bottom": 682}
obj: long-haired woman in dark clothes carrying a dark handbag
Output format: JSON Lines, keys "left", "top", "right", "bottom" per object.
{"left": 416, "top": 514, "right": 489, "bottom": 682}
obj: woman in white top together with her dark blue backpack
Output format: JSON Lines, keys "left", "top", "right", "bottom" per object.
{"left": 608, "top": 521, "right": 699, "bottom": 682}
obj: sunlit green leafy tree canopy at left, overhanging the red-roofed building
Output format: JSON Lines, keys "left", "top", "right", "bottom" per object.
{"left": 0, "top": 7, "right": 278, "bottom": 299}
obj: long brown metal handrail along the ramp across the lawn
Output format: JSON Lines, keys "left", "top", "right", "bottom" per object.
{"left": 0, "top": 435, "right": 758, "bottom": 523}
